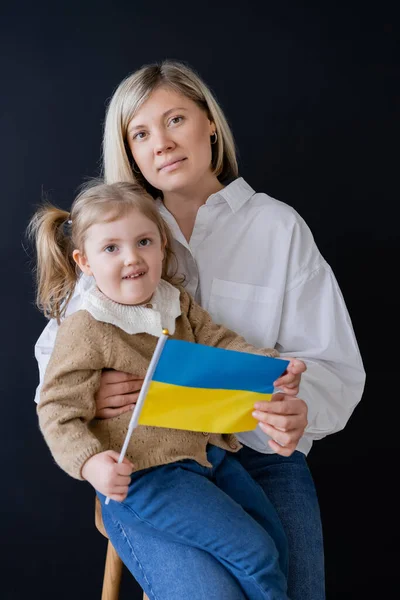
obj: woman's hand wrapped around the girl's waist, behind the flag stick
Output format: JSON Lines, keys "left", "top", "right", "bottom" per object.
{"left": 95, "top": 370, "right": 143, "bottom": 419}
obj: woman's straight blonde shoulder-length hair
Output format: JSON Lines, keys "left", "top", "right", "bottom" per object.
{"left": 103, "top": 60, "right": 238, "bottom": 197}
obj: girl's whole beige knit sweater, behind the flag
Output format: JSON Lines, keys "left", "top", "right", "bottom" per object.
{"left": 37, "top": 282, "right": 278, "bottom": 479}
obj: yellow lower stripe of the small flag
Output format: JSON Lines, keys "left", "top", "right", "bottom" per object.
{"left": 139, "top": 381, "right": 271, "bottom": 433}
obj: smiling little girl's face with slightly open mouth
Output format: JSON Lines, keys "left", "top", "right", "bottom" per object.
{"left": 73, "top": 209, "right": 164, "bottom": 305}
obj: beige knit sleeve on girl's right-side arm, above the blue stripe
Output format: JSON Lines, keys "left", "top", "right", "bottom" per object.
{"left": 181, "top": 289, "right": 279, "bottom": 357}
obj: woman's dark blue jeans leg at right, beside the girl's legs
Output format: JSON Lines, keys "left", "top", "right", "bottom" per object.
{"left": 232, "top": 446, "right": 325, "bottom": 600}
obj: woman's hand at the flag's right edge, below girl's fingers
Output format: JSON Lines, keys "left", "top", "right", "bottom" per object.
{"left": 252, "top": 393, "right": 308, "bottom": 456}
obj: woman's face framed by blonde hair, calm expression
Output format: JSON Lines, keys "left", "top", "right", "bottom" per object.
{"left": 127, "top": 87, "right": 215, "bottom": 193}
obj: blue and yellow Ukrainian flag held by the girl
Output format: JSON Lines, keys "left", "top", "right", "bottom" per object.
{"left": 139, "top": 339, "right": 289, "bottom": 433}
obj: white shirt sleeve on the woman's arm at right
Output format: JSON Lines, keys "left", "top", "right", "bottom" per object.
{"left": 276, "top": 219, "right": 365, "bottom": 440}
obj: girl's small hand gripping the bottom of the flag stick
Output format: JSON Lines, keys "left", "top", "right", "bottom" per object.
{"left": 82, "top": 450, "right": 133, "bottom": 502}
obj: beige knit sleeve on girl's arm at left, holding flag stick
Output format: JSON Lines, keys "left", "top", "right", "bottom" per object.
{"left": 37, "top": 311, "right": 112, "bottom": 479}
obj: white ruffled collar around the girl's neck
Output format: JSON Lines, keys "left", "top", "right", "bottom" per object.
{"left": 80, "top": 279, "right": 182, "bottom": 337}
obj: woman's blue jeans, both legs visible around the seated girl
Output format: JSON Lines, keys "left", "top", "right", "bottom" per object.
{"left": 104, "top": 447, "right": 325, "bottom": 600}
